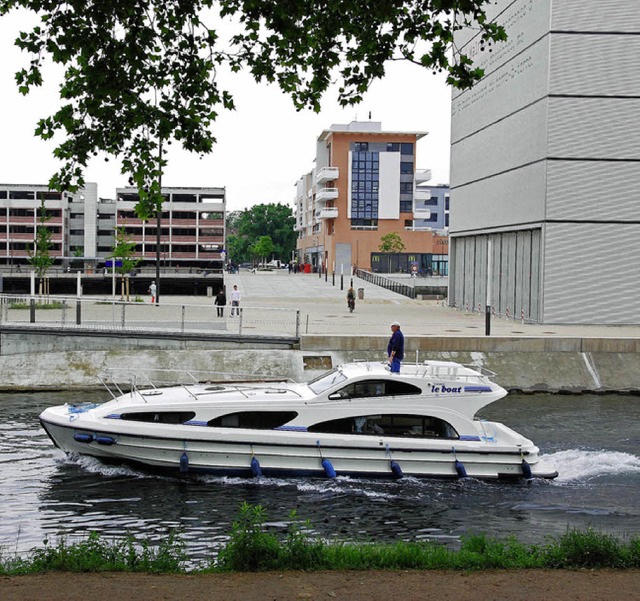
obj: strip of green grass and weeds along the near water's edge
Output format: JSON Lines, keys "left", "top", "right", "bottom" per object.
{"left": 0, "top": 503, "right": 640, "bottom": 575}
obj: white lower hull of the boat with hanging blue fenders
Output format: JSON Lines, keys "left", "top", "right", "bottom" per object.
{"left": 40, "top": 410, "right": 557, "bottom": 480}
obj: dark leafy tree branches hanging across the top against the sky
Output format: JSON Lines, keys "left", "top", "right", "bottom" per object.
{"left": 0, "top": 0, "right": 506, "bottom": 219}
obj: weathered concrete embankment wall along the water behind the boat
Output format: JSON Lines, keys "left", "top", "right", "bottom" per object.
{"left": 0, "top": 329, "right": 640, "bottom": 393}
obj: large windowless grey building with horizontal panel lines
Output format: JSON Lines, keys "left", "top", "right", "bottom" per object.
{"left": 449, "top": 0, "right": 640, "bottom": 324}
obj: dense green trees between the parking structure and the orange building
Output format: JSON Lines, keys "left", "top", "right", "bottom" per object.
{"left": 227, "top": 203, "right": 296, "bottom": 265}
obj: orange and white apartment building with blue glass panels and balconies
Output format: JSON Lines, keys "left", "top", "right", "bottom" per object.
{"left": 295, "top": 121, "right": 448, "bottom": 273}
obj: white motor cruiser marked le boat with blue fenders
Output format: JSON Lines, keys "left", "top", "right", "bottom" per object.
{"left": 40, "top": 361, "right": 558, "bottom": 479}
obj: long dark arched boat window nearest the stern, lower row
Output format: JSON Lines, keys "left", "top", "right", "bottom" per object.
{"left": 308, "top": 414, "right": 458, "bottom": 439}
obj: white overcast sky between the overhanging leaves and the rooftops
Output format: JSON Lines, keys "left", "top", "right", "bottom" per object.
{"left": 0, "top": 15, "right": 451, "bottom": 211}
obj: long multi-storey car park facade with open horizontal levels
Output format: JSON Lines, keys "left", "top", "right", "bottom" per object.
{"left": 0, "top": 183, "right": 226, "bottom": 271}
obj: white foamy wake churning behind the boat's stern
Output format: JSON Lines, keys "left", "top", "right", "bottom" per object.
{"left": 541, "top": 449, "right": 640, "bottom": 482}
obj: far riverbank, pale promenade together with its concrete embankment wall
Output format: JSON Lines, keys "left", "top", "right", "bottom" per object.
{"left": 0, "top": 272, "right": 640, "bottom": 394}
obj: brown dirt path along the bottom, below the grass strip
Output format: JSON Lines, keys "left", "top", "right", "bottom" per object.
{"left": 0, "top": 570, "right": 640, "bottom": 601}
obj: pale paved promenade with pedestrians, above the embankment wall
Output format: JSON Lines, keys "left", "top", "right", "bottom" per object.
{"left": 2, "top": 270, "right": 640, "bottom": 339}
